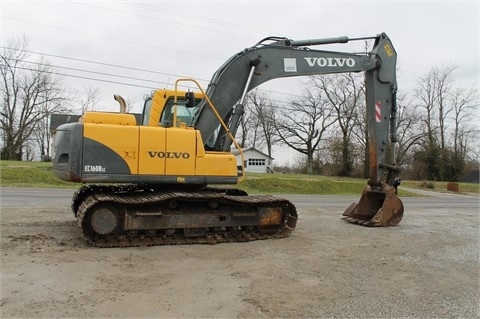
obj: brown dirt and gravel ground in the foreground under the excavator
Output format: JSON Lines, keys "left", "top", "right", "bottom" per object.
{"left": 0, "top": 191, "right": 480, "bottom": 318}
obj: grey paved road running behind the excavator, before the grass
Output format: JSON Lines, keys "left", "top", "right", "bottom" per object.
{"left": 0, "top": 187, "right": 480, "bottom": 212}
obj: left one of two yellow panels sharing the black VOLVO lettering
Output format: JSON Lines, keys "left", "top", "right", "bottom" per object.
{"left": 138, "top": 125, "right": 167, "bottom": 175}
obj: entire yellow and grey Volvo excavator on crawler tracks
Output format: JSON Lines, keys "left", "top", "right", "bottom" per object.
{"left": 53, "top": 33, "right": 403, "bottom": 247}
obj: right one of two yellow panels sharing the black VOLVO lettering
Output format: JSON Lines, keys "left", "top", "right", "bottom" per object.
{"left": 165, "top": 127, "right": 197, "bottom": 177}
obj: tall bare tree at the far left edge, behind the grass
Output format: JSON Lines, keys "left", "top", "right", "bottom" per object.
{"left": 0, "top": 39, "right": 69, "bottom": 160}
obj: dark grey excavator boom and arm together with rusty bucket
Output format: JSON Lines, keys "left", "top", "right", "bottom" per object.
{"left": 192, "top": 33, "right": 403, "bottom": 226}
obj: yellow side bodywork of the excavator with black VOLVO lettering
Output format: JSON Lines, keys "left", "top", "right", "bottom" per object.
{"left": 84, "top": 120, "right": 237, "bottom": 181}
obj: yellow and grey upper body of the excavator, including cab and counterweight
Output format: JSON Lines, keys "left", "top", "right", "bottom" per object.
{"left": 56, "top": 90, "right": 239, "bottom": 184}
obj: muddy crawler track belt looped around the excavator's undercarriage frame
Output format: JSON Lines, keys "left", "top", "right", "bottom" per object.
{"left": 74, "top": 191, "right": 297, "bottom": 247}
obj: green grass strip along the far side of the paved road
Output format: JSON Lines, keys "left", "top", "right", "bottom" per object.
{"left": 0, "top": 161, "right": 480, "bottom": 196}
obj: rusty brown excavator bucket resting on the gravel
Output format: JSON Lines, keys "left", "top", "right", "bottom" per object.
{"left": 342, "top": 184, "right": 403, "bottom": 227}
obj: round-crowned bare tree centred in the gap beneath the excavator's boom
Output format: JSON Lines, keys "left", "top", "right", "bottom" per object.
{"left": 275, "top": 88, "right": 334, "bottom": 174}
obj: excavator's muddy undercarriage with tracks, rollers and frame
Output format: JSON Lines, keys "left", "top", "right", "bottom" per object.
{"left": 72, "top": 184, "right": 297, "bottom": 247}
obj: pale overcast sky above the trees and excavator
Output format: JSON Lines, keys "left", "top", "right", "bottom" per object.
{"left": 0, "top": 0, "right": 480, "bottom": 164}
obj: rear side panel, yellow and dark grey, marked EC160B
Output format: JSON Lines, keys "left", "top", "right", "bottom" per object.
{"left": 81, "top": 123, "right": 139, "bottom": 177}
